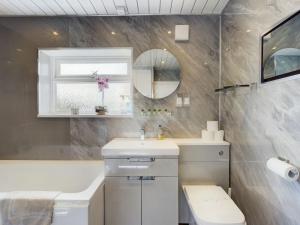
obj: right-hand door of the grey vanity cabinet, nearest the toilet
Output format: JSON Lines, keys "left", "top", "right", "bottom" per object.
{"left": 142, "top": 177, "right": 178, "bottom": 225}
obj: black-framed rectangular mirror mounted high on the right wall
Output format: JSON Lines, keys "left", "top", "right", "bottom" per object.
{"left": 262, "top": 12, "right": 300, "bottom": 82}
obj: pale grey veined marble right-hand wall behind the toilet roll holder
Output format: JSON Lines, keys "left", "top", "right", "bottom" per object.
{"left": 221, "top": 0, "right": 300, "bottom": 225}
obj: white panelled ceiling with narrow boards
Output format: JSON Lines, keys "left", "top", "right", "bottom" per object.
{"left": 0, "top": 0, "right": 229, "bottom": 16}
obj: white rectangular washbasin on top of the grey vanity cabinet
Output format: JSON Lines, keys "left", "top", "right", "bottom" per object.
{"left": 102, "top": 138, "right": 179, "bottom": 157}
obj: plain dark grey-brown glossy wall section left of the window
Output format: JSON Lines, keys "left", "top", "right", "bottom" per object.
{"left": 0, "top": 18, "right": 70, "bottom": 159}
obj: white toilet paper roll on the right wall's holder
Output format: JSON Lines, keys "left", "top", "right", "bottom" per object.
{"left": 267, "top": 158, "right": 299, "bottom": 181}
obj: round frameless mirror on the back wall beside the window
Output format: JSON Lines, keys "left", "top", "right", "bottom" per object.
{"left": 133, "top": 49, "right": 180, "bottom": 99}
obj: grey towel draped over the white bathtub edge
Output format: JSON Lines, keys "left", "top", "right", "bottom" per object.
{"left": 0, "top": 191, "right": 58, "bottom": 225}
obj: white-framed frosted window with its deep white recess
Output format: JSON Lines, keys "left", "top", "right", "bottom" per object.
{"left": 39, "top": 48, "right": 132, "bottom": 117}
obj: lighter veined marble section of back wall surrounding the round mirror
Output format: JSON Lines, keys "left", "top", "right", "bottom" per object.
{"left": 70, "top": 16, "right": 219, "bottom": 158}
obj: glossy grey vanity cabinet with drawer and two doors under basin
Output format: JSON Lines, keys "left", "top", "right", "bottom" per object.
{"left": 105, "top": 157, "right": 178, "bottom": 225}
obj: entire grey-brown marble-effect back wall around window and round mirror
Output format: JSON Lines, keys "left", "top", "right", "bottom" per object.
{"left": 0, "top": 16, "right": 219, "bottom": 159}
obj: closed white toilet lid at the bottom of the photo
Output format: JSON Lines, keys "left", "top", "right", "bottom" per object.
{"left": 183, "top": 185, "right": 246, "bottom": 225}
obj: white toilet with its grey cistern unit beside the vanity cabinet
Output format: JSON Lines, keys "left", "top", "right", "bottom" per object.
{"left": 179, "top": 141, "right": 246, "bottom": 225}
